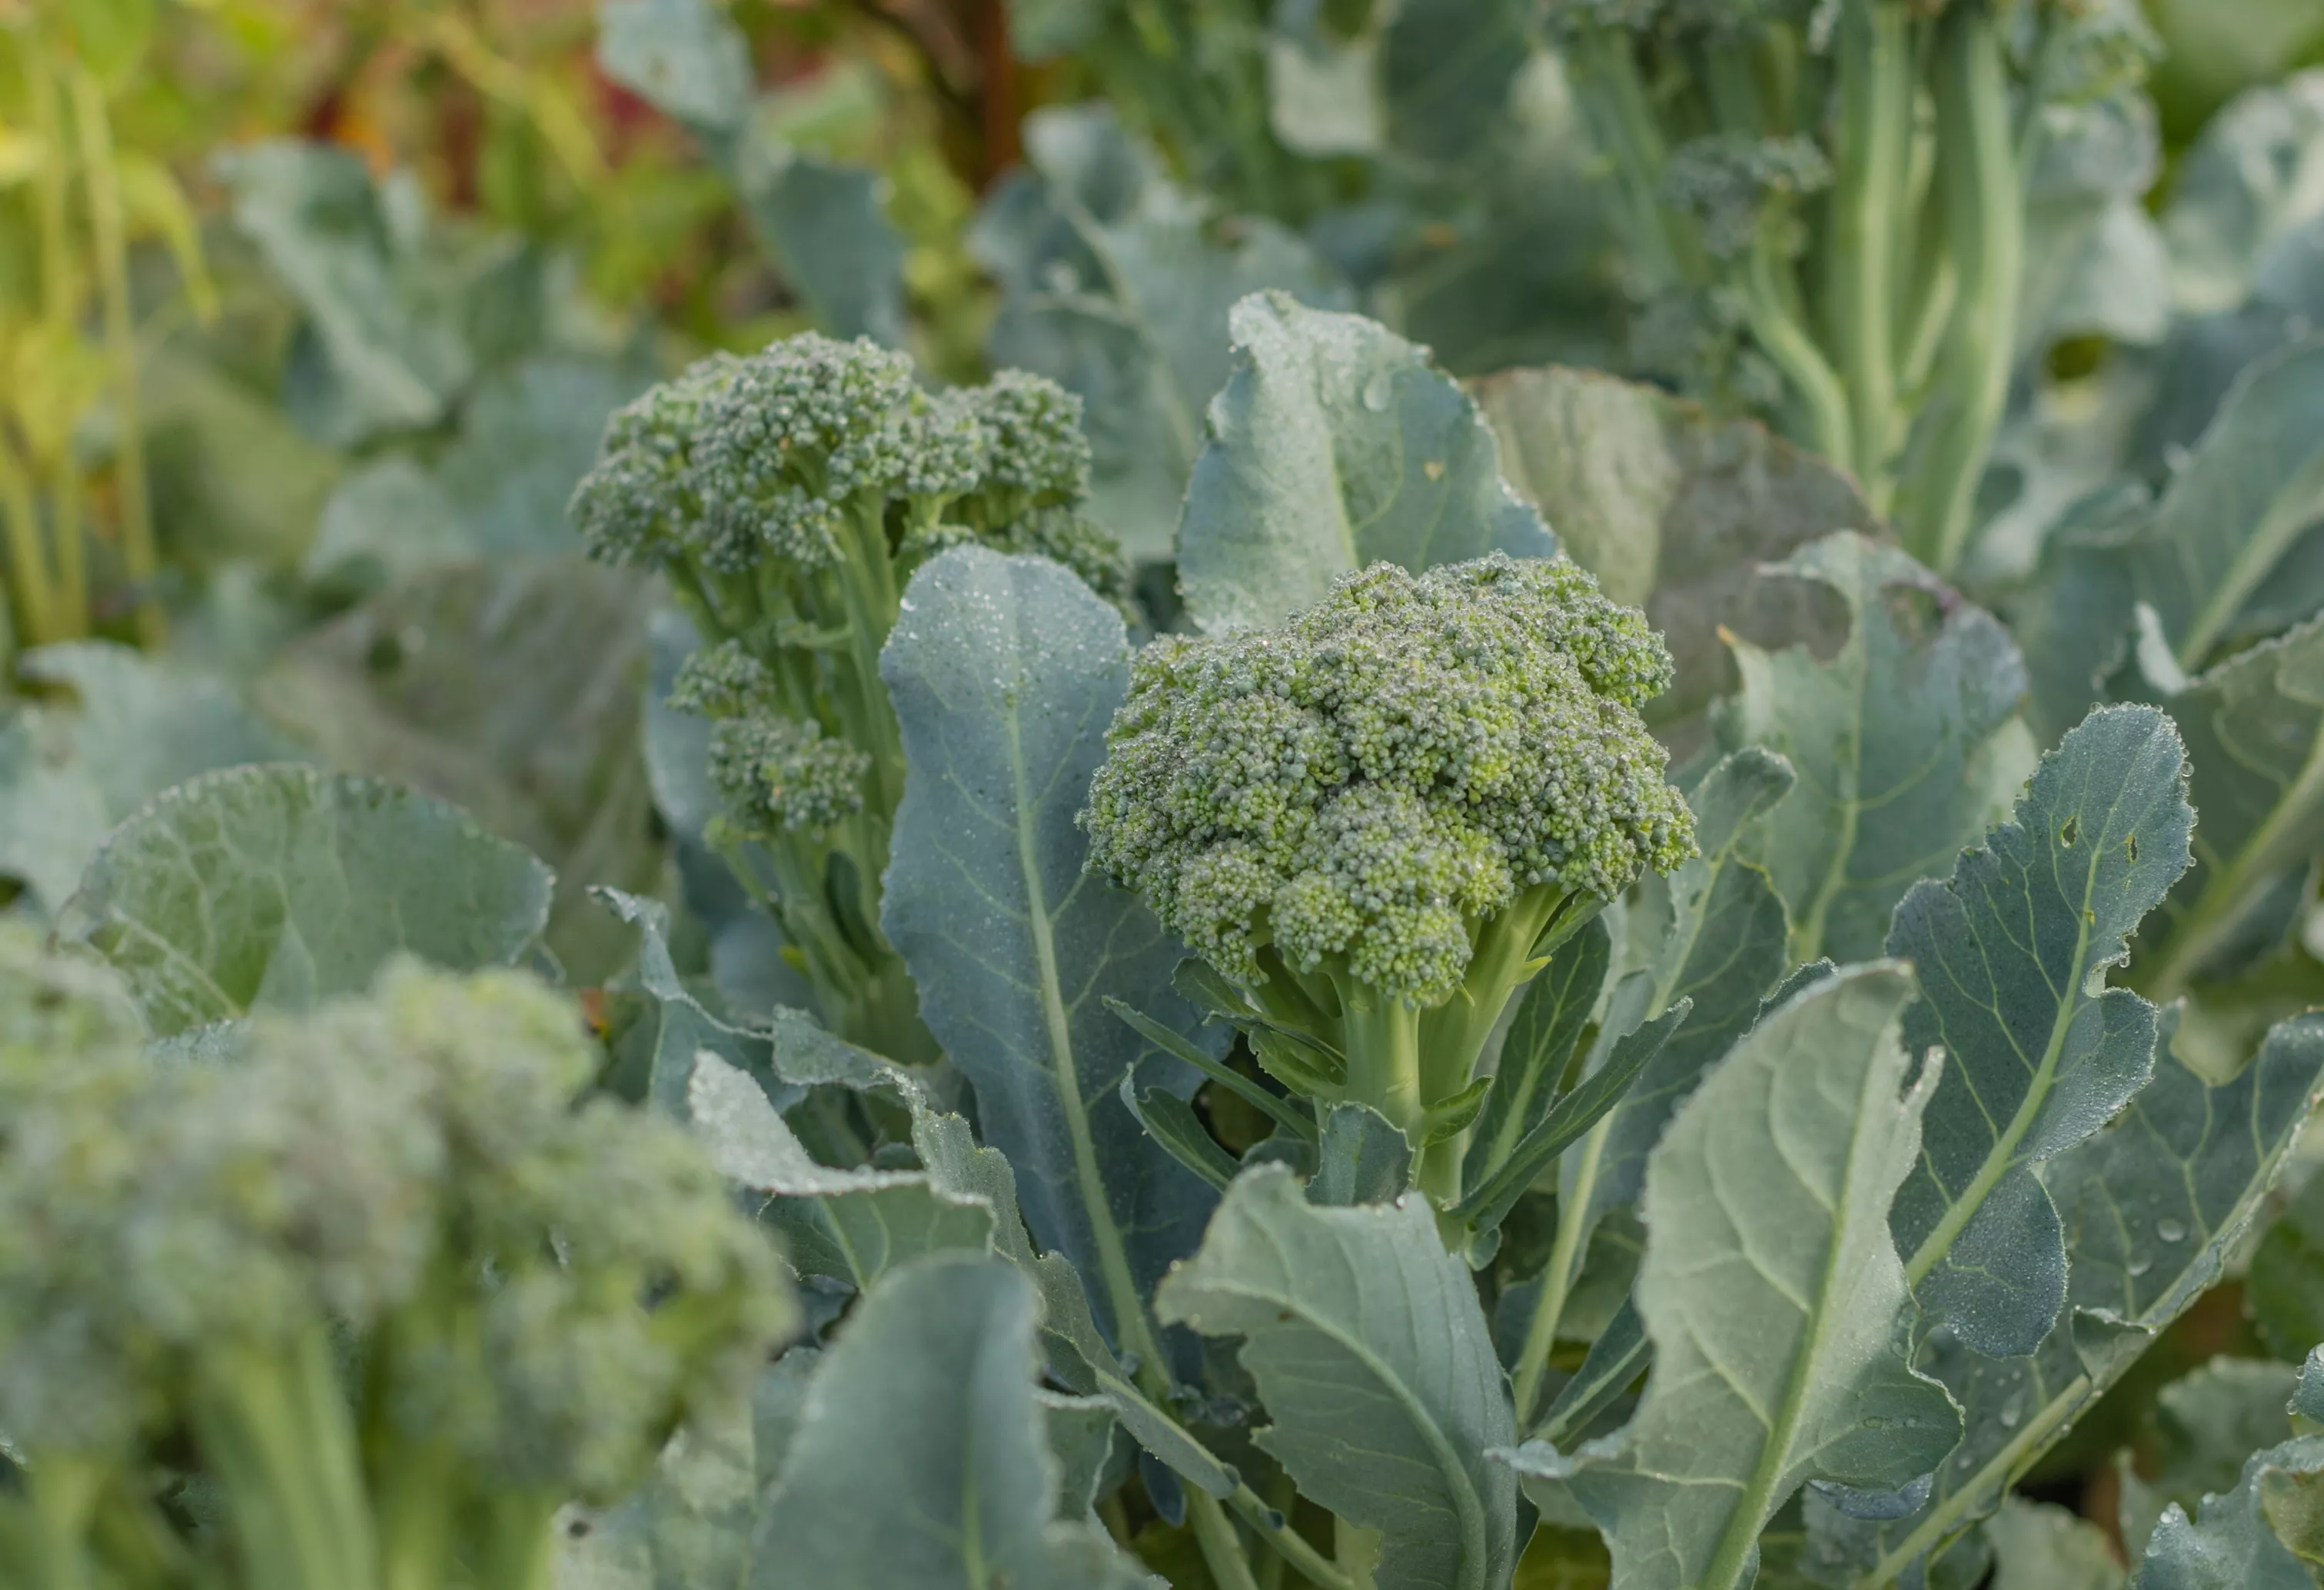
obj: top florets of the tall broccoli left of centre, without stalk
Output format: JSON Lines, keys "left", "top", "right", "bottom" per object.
{"left": 572, "top": 332, "right": 1090, "bottom": 572}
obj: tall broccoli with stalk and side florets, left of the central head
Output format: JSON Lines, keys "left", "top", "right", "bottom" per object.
{"left": 572, "top": 334, "right": 1129, "bottom": 1060}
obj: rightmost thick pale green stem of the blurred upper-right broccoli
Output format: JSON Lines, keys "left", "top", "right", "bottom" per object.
{"left": 1901, "top": 0, "right": 2024, "bottom": 574}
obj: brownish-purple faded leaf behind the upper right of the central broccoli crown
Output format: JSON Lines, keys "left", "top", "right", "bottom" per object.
{"left": 1469, "top": 365, "right": 1880, "bottom": 756}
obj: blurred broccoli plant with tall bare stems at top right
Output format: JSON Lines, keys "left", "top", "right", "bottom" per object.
{"left": 1550, "top": 0, "right": 2152, "bottom": 570}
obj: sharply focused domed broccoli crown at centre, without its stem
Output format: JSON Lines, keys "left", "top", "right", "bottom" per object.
{"left": 1083, "top": 554, "right": 1694, "bottom": 1004}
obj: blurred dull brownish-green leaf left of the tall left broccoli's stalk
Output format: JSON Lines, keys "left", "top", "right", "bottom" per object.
{"left": 251, "top": 556, "right": 663, "bottom": 983}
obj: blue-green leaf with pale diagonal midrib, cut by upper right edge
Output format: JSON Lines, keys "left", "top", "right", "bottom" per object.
{"left": 2126, "top": 337, "right": 2324, "bottom": 672}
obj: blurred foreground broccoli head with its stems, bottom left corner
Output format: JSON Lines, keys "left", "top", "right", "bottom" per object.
{"left": 0, "top": 930, "right": 790, "bottom": 1590}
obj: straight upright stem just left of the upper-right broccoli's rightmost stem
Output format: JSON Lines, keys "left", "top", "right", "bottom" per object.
{"left": 1824, "top": 0, "right": 1913, "bottom": 497}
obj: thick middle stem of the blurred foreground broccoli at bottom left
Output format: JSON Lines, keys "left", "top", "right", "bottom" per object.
{"left": 191, "top": 1320, "right": 379, "bottom": 1590}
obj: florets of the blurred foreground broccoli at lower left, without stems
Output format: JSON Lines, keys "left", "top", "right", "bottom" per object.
{"left": 0, "top": 930, "right": 788, "bottom": 1497}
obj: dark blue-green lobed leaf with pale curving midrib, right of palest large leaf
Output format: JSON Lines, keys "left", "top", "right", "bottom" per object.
{"left": 1887, "top": 707, "right": 2194, "bottom": 1358}
